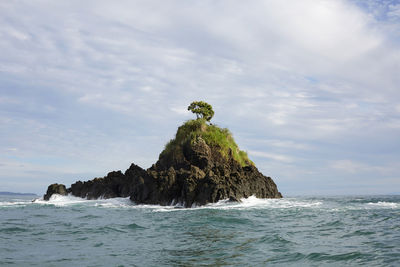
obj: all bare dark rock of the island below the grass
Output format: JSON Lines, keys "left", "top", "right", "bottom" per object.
{"left": 45, "top": 122, "right": 282, "bottom": 207}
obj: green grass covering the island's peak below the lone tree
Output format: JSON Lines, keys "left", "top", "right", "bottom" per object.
{"left": 160, "top": 119, "right": 254, "bottom": 167}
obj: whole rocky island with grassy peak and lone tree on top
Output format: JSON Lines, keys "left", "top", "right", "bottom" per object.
{"left": 43, "top": 101, "right": 282, "bottom": 207}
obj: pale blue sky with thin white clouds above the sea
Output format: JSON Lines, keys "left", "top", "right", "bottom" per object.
{"left": 0, "top": 0, "right": 400, "bottom": 196}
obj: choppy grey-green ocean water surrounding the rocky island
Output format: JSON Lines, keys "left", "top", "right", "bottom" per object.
{"left": 0, "top": 196, "right": 400, "bottom": 267}
